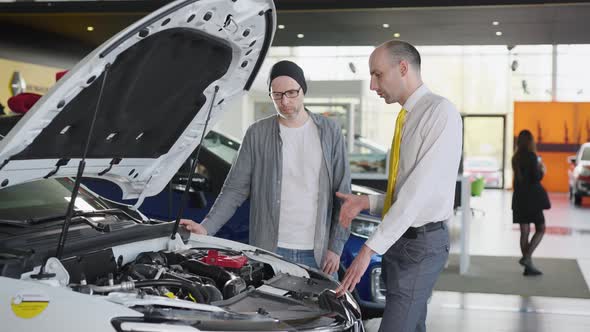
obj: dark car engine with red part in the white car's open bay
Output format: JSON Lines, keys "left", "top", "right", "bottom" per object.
{"left": 69, "top": 249, "right": 274, "bottom": 304}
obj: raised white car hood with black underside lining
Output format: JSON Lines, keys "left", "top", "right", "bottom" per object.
{"left": 0, "top": 0, "right": 276, "bottom": 201}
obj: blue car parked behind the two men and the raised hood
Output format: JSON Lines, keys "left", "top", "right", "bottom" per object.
{"left": 82, "top": 131, "right": 385, "bottom": 319}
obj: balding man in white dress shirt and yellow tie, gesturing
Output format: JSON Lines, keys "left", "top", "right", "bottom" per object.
{"left": 337, "top": 40, "right": 462, "bottom": 332}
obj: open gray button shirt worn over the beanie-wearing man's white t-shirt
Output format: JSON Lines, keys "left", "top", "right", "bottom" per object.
{"left": 202, "top": 110, "right": 351, "bottom": 265}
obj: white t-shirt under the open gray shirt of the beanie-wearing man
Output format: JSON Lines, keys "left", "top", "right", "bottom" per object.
{"left": 278, "top": 118, "right": 322, "bottom": 250}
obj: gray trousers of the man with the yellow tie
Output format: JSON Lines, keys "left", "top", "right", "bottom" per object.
{"left": 379, "top": 223, "right": 449, "bottom": 332}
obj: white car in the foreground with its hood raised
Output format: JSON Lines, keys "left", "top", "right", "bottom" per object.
{"left": 0, "top": 0, "right": 363, "bottom": 332}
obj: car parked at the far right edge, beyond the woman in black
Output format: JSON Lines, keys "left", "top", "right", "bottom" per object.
{"left": 567, "top": 142, "right": 590, "bottom": 206}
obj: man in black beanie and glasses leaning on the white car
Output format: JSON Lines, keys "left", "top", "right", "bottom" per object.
{"left": 181, "top": 61, "right": 351, "bottom": 276}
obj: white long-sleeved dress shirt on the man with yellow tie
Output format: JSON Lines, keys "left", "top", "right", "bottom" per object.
{"left": 366, "top": 84, "right": 463, "bottom": 255}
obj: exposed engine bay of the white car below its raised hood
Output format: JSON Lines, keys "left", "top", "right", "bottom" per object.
{"left": 0, "top": 234, "right": 360, "bottom": 331}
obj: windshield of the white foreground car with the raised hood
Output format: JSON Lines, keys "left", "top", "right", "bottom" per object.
{"left": 0, "top": 178, "right": 108, "bottom": 221}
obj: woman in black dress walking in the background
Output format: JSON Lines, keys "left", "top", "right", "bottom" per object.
{"left": 512, "top": 130, "right": 550, "bottom": 276}
